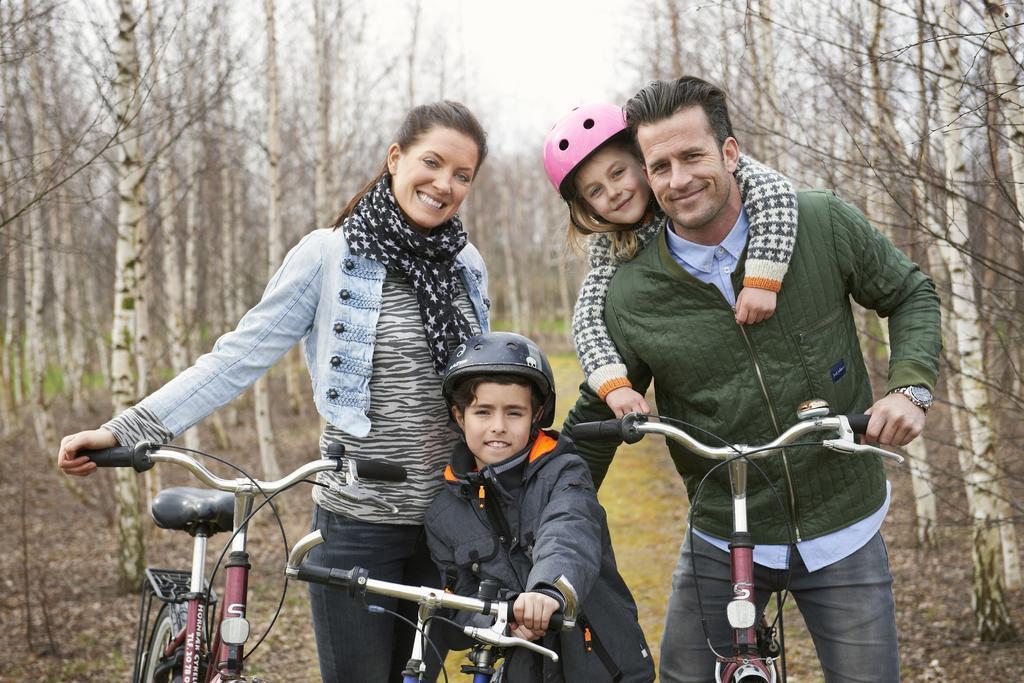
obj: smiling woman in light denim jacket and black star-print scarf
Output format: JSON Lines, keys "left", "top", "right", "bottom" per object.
{"left": 58, "top": 101, "right": 489, "bottom": 681}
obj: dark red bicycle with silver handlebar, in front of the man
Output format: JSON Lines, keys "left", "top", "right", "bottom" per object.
{"left": 572, "top": 399, "right": 903, "bottom": 683}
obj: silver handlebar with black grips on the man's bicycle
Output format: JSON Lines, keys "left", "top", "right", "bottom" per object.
{"left": 570, "top": 413, "right": 903, "bottom": 464}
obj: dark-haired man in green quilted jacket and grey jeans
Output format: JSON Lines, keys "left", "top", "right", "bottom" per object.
{"left": 565, "top": 77, "right": 940, "bottom": 683}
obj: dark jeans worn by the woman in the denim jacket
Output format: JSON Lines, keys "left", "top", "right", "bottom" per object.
{"left": 309, "top": 505, "right": 445, "bottom": 683}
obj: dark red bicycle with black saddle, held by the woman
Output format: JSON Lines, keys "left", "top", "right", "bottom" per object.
{"left": 82, "top": 442, "right": 406, "bottom": 683}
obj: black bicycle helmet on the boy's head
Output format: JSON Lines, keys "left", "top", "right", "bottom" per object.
{"left": 441, "top": 332, "right": 555, "bottom": 427}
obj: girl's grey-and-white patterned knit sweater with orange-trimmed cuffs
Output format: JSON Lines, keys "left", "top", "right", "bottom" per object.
{"left": 572, "top": 156, "right": 797, "bottom": 398}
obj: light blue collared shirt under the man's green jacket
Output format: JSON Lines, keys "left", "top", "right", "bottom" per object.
{"left": 665, "top": 210, "right": 892, "bottom": 571}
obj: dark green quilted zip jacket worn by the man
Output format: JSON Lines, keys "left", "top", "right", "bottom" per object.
{"left": 565, "top": 191, "right": 941, "bottom": 544}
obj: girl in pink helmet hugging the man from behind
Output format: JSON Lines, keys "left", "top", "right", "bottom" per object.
{"left": 544, "top": 103, "right": 797, "bottom": 417}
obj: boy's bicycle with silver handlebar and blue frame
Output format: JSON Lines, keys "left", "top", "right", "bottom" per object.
{"left": 285, "top": 530, "right": 577, "bottom": 683}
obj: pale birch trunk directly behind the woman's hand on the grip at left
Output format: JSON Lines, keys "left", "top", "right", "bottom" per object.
{"left": 111, "top": 0, "right": 145, "bottom": 591}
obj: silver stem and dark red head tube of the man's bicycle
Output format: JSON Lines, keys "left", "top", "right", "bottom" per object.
{"left": 715, "top": 458, "right": 776, "bottom": 683}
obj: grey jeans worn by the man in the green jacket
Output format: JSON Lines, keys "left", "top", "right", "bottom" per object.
{"left": 659, "top": 533, "right": 899, "bottom": 683}
